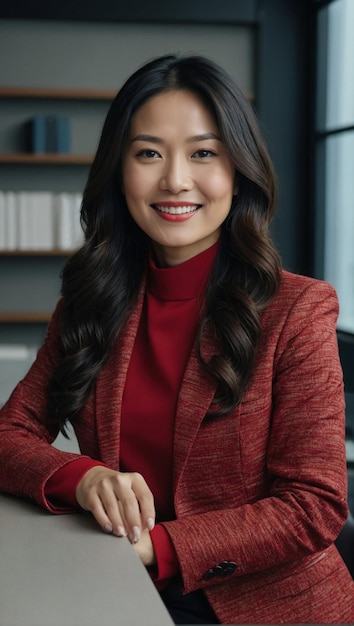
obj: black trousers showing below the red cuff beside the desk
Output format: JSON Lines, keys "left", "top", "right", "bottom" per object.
{"left": 160, "top": 578, "right": 220, "bottom": 624}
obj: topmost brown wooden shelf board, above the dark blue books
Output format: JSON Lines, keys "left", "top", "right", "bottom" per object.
{"left": 0, "top": 87, "right": 117, "bottom": 101}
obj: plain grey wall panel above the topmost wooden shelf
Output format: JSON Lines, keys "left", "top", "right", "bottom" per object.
{"left": 0, "top": 20, "right": 255, "bottom": 92}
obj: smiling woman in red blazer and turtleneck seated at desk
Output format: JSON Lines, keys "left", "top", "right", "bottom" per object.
{"left": 0, "top": 55, "right": 354, "bottom": 624}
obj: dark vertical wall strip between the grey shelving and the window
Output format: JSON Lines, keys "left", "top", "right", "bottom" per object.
{"left": 257, "top": 0, "right": 314, "bottom": 274}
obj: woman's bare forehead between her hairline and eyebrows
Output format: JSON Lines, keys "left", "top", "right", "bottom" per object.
{"left": 131, "top": 90, "right": 217, "bottom": 134}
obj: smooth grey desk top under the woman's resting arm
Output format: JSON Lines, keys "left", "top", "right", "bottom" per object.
{"left": 0, "top": 495, "right": 172, "bottom": 626}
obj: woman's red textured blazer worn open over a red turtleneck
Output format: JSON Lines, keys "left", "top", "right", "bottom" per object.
{"left": 0, "top": 272, "right": 354, "bottom": 624}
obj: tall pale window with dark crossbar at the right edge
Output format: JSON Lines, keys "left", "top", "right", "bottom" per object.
{"left": 316, "top": 0, "right": 354, "bottom": 333}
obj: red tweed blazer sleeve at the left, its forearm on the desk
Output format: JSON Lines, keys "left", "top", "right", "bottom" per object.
{"left": 0, "top": 304, "right": 94, "bottom": 513}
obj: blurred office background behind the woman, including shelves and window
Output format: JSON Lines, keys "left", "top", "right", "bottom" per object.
{"left": 0, "top": 0, "right": 354, "bottom": 502}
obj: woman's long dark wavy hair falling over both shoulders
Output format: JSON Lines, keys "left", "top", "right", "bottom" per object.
{"left": 48, "top": 55, "right": 281, "bottom": 434}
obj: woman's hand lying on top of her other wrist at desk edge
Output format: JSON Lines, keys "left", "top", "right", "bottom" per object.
{"left": 76, "top": 466, "right": 155, "bottom": 540}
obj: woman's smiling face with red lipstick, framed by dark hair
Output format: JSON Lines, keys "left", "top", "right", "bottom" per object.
{"left": 123, "top": 91, "right": 235, "bottom": 265}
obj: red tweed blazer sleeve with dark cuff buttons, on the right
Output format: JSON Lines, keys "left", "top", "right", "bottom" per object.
{"left": 159, "top": 281, "right": 347, "bottom": 592}
